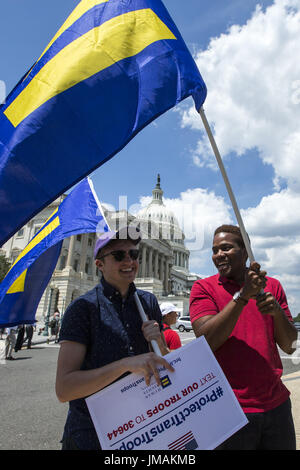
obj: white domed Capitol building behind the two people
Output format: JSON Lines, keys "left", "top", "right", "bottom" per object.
{"left": 0, "top": 175, "right": 199, "bottom": 321}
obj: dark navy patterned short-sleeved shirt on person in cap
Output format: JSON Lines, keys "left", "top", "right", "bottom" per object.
{"left": 59, "top": 278, "right": 162, "bottom": 450}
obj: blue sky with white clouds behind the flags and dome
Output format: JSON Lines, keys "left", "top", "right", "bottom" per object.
{"left": 0, "top": 0, "right": 300, "bottom": 315}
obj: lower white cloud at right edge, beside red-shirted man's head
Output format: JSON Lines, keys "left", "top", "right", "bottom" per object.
{"left": 242, "top": 189, "right": 300, "bottom": 316}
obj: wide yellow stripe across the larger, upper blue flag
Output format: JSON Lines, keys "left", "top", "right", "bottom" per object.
{"left": 4, "top": 9, "right": 176, "bottom": 127}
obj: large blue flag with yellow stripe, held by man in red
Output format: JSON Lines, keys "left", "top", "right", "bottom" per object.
{"left": 0, "top": 0, "right": 206, "bottom": 245}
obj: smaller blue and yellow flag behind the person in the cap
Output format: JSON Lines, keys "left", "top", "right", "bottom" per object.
{"left": 0, "top": 179, "right": 110, "bottom": 327}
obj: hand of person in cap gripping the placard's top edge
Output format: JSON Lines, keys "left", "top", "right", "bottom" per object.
{"left": 126, "top": 352, "right": 174, "bottom": 386}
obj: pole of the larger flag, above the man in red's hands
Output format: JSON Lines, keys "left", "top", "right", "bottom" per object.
{"left": 199, "top": 106, "right": 255, "bottom": 263}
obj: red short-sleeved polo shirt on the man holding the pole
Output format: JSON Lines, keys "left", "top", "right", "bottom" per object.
{"left": 190, "top": 274, "right": 293, "bottom": 413}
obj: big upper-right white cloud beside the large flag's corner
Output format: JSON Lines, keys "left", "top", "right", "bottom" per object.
{"left": 182, "top": 0, "right": 300, "bottom": 191}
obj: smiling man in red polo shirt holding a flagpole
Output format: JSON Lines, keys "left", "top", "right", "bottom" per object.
{"left": 190, "top": 225, "right": 297, "bottom": 450}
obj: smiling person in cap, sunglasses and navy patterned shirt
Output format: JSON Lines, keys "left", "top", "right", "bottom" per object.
{"left": 56, "top": 227, "right": 173, "bottom": 450}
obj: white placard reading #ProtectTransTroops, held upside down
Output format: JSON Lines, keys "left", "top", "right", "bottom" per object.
{"left": 86, "top": 337, "right": 248, "bottom": 451}
